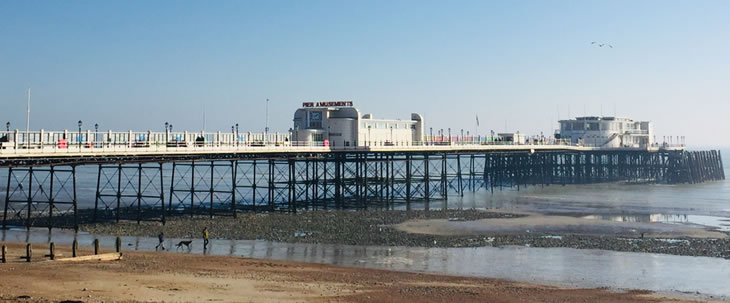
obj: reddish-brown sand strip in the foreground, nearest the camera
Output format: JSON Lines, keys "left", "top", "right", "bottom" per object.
{"left": 0, "top": 243, "right": 706, "bottom": 302}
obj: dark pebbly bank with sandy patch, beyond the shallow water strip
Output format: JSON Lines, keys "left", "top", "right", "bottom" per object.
{"left": 81, "top": 210, "right": 730, "bottom": 259}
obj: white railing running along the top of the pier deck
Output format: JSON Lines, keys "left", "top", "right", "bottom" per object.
{"left": 0, "top": 130, "right": 670, "bottom": 155}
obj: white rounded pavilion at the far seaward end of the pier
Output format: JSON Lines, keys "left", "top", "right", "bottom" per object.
{"left": 555, "top": 117, "right": 654, "bottom": 148}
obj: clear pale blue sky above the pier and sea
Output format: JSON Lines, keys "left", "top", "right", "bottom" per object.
{"left": 0, "top": 0, "right": 730, "bottom": 146}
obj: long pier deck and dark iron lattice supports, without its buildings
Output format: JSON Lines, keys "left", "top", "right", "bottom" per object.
{"left": 0, "top": 131, "right": 725, "bottom": 228}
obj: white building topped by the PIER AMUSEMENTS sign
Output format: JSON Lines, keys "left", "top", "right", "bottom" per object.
{"left": 290, "top": 101, "right": 424, "bottom": 148}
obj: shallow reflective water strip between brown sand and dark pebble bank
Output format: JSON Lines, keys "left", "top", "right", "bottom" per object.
{"left": 0, "top": 229, "right": 730, "bottom": 298}
